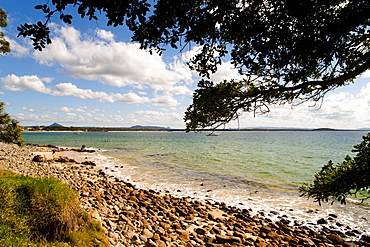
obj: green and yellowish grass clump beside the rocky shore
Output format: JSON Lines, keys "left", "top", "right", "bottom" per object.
{"left": 0, "top": 169, "right": 109, "bottom": 247}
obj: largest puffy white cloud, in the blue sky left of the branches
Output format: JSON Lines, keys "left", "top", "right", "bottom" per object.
{"left": 33, "top": 24, "right": 192, "bottom": 91}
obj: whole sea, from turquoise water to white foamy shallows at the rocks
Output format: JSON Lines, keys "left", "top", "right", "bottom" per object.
{"left": 23, "top": 131, "right": 370, "bottom": 236}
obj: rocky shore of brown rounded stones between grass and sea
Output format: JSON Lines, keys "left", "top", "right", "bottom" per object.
{"left": 0, "top": 143, "right": 370, "bottom": 246}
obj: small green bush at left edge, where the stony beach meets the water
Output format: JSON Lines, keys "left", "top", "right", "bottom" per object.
{"left": 0, "top": 102, "right": 24, "bottom": 146}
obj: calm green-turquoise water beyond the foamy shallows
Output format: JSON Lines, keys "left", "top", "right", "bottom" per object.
{"left": 24, "top": 131, "right": 366, "bottom": 188}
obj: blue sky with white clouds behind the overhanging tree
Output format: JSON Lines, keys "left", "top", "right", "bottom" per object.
{"left": 0, "top": 0, "right": 370, "bottom": 129}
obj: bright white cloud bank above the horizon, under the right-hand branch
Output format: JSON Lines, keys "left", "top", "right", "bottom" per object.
{"left": 231, "top": 82, "right": 370, "bottom": 129}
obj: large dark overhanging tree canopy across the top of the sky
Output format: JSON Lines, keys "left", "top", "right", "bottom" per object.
{"left": 18, "top": 0, "right": 370, "bottom": 130}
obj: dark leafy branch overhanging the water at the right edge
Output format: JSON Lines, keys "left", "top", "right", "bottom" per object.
{"left": 299, "top": 133, "right": 370, "bottom": 204}
